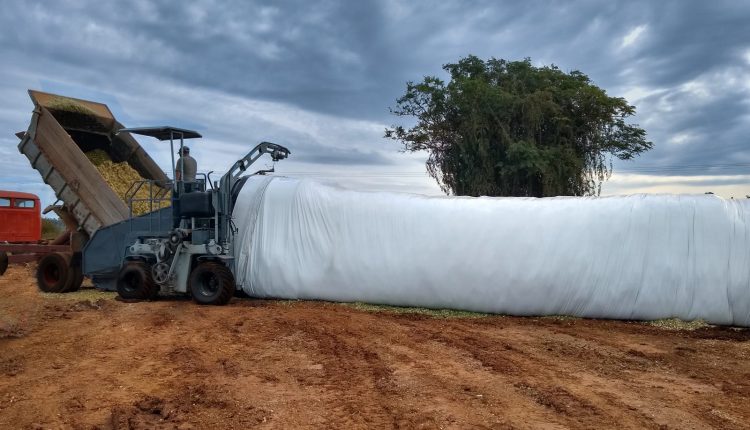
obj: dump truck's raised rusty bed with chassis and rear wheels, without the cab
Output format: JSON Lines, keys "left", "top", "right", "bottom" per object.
{"left": 0, "top": 90, "right": 169, "bottom": 293}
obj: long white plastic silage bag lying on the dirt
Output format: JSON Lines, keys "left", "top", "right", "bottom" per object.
{"left": 234, "top": 177, "right": 750, "bottom": 326}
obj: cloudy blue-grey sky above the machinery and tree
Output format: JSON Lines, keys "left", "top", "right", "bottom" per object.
{"left": 0, "top": 0, "right": 750, "bottom": 208}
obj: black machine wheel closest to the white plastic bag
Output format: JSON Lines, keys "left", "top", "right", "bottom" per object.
{"left": 190, "top": 261, "right": 235, "bottom": 306}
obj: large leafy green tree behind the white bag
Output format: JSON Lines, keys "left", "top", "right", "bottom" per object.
{"left": 385, "top": 56, "right": 652, "bottom": 197}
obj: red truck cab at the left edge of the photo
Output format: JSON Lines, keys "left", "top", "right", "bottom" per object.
{"left": 0, "top": 190, "right": 42, "bottom": 243}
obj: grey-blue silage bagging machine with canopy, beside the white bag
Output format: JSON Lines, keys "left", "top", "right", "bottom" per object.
{"left": 83, "top": 127, "right": 289, "bottom": 305}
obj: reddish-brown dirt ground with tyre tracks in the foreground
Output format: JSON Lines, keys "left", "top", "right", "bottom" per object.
{"left": 0, "top": 267, "right": 750, "bottom": 429}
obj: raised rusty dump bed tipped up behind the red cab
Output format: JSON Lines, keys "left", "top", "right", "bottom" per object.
{"left": 18, "top": 90, "right": 169, "bottom": 236}
